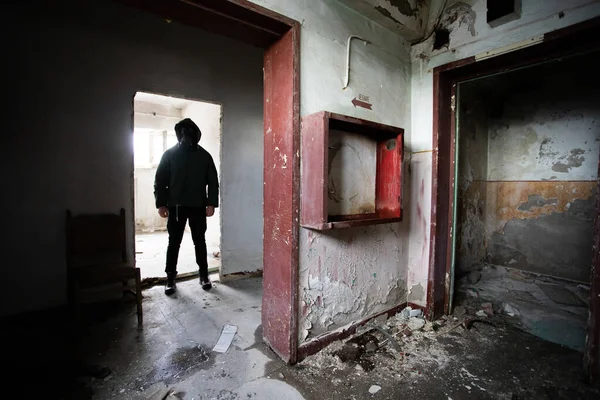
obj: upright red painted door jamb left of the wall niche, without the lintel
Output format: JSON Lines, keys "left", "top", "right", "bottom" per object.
{"left": 262, "top": 28, "right": 300, "bottom": 363}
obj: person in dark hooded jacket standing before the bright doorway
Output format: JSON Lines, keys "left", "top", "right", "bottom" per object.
{"left": 154, "top": 118, "right": 219, "bottom": 294}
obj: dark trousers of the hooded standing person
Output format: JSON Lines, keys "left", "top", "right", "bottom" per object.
{"left": 165, "top": 206, "right": 208, "bottom": 280}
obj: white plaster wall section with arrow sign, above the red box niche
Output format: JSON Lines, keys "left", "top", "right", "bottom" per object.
{"left": 252, "top": 0, "right": 410, "bottom": 125}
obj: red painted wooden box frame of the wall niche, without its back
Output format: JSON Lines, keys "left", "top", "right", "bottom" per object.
{"left": 301, "top": 111, "right": 404, "bottom": 230}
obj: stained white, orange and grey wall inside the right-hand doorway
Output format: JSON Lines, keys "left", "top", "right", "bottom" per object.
{"left": 457, "top": 56, "right": 600, "bottom": 281}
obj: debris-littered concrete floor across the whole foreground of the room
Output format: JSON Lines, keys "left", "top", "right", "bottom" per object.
{"left": 0, "top": 276, "right": 600, "bottom": 400}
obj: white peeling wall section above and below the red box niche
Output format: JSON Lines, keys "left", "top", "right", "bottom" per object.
{"left": 247, "top": 0, "right": 410, "bottom": 340}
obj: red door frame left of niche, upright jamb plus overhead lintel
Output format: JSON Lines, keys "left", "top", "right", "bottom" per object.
{"left": 113, "top": 0, "right": 300, "bottom": 364}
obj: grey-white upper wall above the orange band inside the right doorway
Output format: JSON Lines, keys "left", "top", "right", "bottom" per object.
{"left": 486, "top": 73, "right": 600, "bottom": 181}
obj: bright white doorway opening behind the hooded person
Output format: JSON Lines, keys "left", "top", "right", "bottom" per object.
{"left": 133, "top": 92, "right": 222, "bottom": 279}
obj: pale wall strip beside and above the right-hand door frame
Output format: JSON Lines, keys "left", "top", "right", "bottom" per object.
{"left": 407, "top": 0, "right": 600, "bottom": 305}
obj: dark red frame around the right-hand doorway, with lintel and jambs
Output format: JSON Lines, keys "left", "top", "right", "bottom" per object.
{"left": 426, "top": 18, "right": 600, "bottom": 379}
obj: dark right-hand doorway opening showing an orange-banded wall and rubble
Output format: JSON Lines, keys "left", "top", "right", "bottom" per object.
{"left": 450, "top": 53, "right": 600, "bottom": 352}
